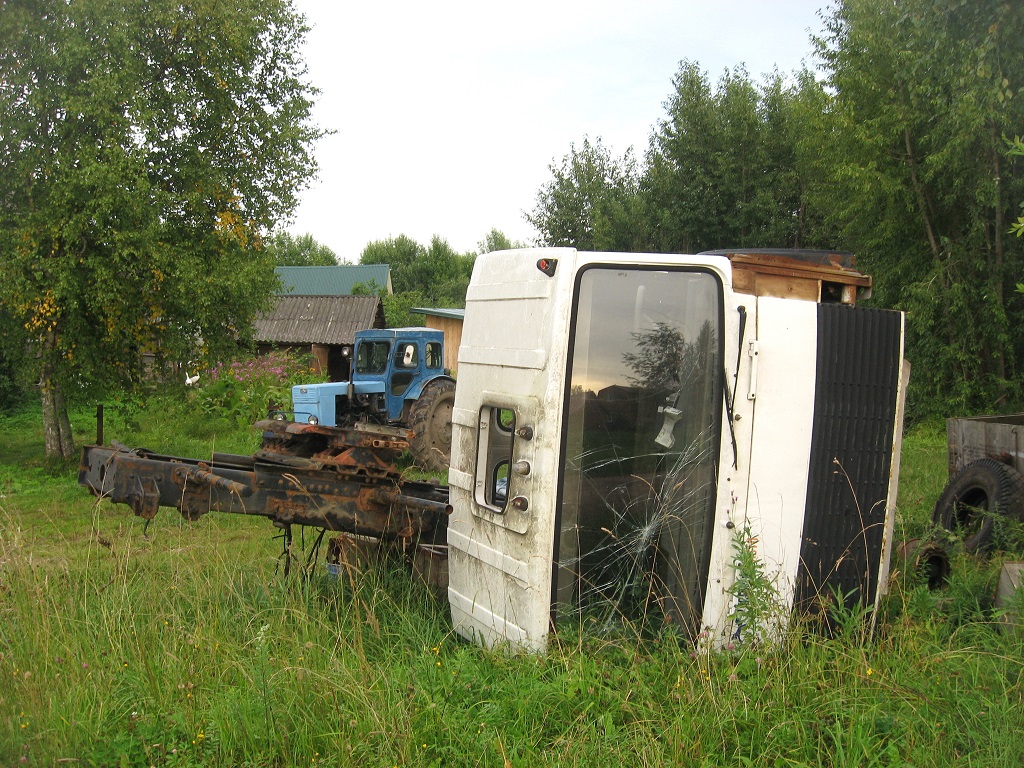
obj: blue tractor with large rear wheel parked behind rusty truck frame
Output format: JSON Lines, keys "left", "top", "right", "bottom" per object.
{"left": 261, "top": 328, "right": 455, "bottom": 471}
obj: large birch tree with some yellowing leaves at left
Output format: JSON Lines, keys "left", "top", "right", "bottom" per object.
{"left": 0, "top": 0, "right": 319, "bottom": 457}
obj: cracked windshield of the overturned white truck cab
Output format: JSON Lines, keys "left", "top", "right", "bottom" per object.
{"left": 555, "top": 267, "right": 723, "bottom": 633}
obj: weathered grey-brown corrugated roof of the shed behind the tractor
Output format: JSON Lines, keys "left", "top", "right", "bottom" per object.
{"left": 256, "top": 296, "right": 384, "bottom": 344}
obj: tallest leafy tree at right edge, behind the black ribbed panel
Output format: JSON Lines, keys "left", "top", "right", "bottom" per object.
{"left": 819, "top": 0, "right": 1024, "bottom": 413}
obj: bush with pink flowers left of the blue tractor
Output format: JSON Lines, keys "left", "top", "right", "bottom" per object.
{"left": 197, "top": 351, "right": 316, "bottom": 428}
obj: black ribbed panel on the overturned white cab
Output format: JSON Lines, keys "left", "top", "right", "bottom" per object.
{"left": 796, "top": 304, "right": 902, "bottom": 611}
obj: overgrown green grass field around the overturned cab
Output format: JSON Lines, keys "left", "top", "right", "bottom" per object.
{"left": 0, "top": 399, "right": 1024, "bottom": 768}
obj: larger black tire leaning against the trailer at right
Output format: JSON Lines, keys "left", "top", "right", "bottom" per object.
{"left": 932, "top": 459, "right": 1024, "bottom": 552}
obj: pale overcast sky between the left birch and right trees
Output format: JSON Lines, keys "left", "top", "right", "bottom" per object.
{"left": 289, "top": 0, "right": 828, "bottom": 262}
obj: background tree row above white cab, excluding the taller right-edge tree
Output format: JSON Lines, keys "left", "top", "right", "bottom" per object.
{"left": 526, "top": 70, "right": 827, "bottom": 253}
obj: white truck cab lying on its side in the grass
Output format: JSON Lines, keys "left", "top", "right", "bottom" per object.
{"left": 447, "top": 249, "right": 906, "bottom": 650}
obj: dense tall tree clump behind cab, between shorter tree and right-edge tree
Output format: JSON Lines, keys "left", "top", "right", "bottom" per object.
{"left": 643, "top": 60, "right": 825, "bottom": 253}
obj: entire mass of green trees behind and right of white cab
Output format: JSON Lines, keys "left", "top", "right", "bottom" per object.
{"left": 527, "top": 0, "right": 1024, "bottom": 419}
